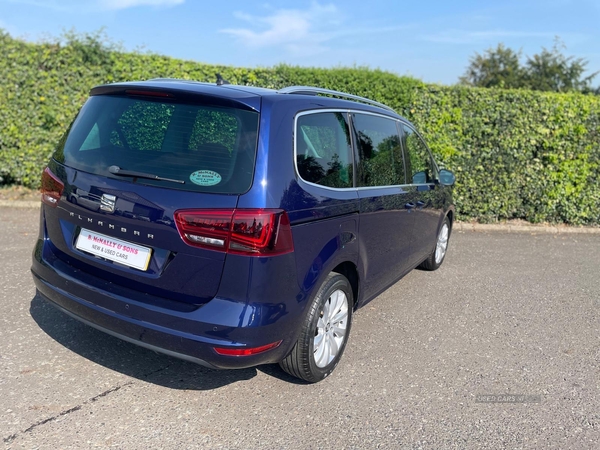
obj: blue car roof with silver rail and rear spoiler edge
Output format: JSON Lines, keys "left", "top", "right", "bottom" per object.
{"left": 90, "top": 78, "right": 401, "bottom": 118}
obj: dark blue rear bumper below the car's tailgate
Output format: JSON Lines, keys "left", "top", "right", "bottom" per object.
{"left": 31, "top": 239, "right": 301, "bottom": 369}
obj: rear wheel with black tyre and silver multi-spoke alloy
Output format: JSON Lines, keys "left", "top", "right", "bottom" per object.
{"left": 279, "top": 272, "right": 354, "bottom": 383}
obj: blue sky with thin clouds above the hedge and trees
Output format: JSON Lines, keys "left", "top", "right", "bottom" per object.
{"left": 0, "top": 0, "right": 600, "bottom": 86}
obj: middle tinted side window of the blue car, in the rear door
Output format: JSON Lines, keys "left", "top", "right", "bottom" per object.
{"left": 352, "top": 114, "right": 404, "bottom": 186}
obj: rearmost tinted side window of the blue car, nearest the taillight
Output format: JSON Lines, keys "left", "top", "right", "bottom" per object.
{"left": 296, "top": 112, "right": 353, "bottom": 188}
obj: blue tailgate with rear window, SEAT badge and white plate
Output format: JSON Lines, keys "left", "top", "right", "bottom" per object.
{"left": 44, "top": 90, "right": 259, "bottom": 304}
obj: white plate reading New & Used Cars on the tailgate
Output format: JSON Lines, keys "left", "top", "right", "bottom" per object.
{"left": 75, "top": 228, "right": 152, "bottom": 270}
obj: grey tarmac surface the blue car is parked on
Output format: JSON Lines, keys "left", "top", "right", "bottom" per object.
{"left": 0, "top": 206, "right": 600, "bottom": 449}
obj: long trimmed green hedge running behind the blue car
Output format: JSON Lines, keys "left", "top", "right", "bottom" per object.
{"left": 0, "top": 31, "right": 600, "bottom": 224}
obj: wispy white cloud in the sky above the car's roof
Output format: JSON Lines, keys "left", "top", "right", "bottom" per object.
{"left": 220, "top": 3, "right": 341, "bottom": 55}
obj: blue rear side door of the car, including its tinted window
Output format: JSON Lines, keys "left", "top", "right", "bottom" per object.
{"left": 352, "top": 113, "right": 414, "bottom": 297}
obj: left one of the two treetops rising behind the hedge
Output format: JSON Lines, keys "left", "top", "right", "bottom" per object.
{"left": 460, "top": 44, "right": 525, "bottom": 89}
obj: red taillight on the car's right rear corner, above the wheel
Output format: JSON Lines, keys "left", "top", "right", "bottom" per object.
{"left": 175, "top": 209, "right": 294, "bottom": 256}
